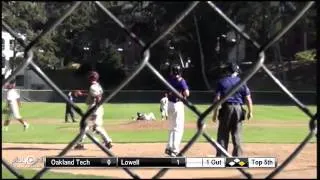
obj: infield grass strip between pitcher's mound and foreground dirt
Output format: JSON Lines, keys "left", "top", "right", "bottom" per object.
{"left": 2, "top": 124, "right": 315, "bottom": 144}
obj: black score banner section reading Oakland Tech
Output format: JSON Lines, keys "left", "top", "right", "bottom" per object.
{"left": 45, "top": 157, "right": 117, "bottom": 168}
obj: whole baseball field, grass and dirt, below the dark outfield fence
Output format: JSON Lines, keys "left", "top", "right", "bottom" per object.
{"left": 2, "top": 102, "right": 317, "bottom": 179}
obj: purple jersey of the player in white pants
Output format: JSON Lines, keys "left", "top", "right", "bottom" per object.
{"left": 168, "top": 76, "right": 189, "bottom": 103}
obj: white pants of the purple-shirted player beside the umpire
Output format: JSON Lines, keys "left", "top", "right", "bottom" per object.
{"left": 167, "top": 101, "right": 184, "bottom": 153}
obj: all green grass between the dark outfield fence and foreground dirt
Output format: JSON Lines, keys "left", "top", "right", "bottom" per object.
{"left": 2, "top": 103, "right": 316, "bottom": 143}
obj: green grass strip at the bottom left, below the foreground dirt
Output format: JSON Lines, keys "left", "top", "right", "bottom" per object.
{"left": 1, "top": 166, "right": 112, "bottom": 179}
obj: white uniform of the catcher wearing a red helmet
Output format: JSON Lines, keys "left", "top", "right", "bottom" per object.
{"left": 80, "top": 81, "right": 112, "bottom": 142}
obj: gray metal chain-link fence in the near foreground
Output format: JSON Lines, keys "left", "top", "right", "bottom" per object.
{"left": 2, "top": 1, "right": 318, "bottom": 178}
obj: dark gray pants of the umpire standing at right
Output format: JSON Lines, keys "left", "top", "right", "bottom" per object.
{"left": 217, "top": 104, "right": 242, "bottom": 157}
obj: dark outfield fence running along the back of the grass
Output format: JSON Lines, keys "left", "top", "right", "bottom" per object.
{"left": 2, "top": 89, "right": 316, "bottom": 105}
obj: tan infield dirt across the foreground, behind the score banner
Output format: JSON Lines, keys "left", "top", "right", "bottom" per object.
{"left": 2, "top": 143, "right": 317, "bottom": 179}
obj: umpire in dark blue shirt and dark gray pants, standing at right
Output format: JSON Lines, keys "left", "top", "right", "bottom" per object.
{"left": 212, "top": 63, "right": 252, "bottom": 157}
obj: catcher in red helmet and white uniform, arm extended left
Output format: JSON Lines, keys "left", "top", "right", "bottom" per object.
{"left": 75, "top": 71, "right": 112, "bottom": 149}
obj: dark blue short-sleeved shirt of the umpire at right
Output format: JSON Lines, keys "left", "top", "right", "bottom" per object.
{"left": 216, "top": 76, "right": 250, "bottom": 104}
